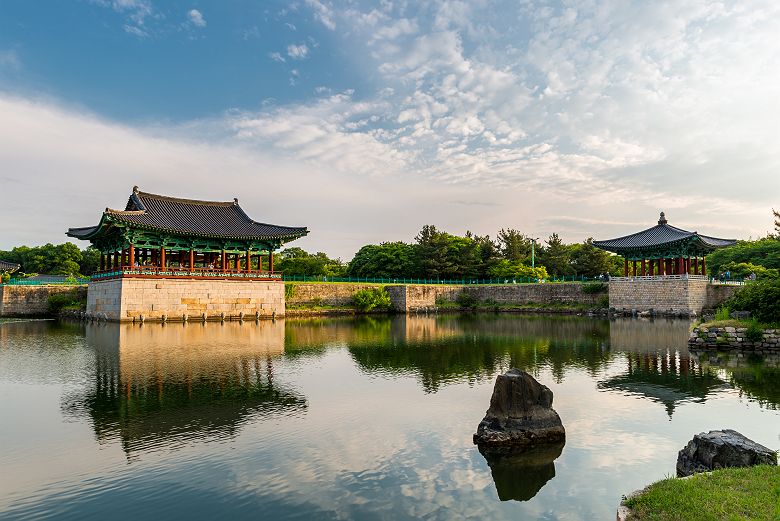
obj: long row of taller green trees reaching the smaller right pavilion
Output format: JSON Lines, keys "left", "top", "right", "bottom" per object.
{"left": 347, "top": 225, "right": 623, "bottom": 279}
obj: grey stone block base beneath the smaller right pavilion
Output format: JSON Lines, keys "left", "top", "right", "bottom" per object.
{"left": 609, "top": 277, "right": 710, "bottom": 315}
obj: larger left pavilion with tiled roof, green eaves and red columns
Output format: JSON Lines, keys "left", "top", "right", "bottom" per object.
{"left": 67, "top": 186, "right": 309, "bottom": 280}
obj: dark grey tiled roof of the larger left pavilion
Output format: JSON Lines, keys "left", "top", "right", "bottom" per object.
{"left": 68, "top": 187, "right": 309, "bottom": 240}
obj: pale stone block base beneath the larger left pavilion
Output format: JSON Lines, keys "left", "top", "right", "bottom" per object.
{"left": 87, "top": 278, "right": 285, "bottom": 321}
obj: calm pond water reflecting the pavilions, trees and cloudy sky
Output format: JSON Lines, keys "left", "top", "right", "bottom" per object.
{"left": 0, "top": 315, "right": 780, "bottom": 520}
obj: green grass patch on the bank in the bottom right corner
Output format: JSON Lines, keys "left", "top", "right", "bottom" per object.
{"left": 626, "top": 465, "right": 780, "bottom": 521}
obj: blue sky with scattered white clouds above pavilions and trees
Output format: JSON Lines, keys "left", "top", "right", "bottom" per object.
{"left": 0, "top": 0, "right": 780, "bottom": 261}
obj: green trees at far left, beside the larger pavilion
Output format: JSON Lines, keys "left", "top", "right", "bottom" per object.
{"left": 0, "top": 242, "right": 100, "bottom": 277}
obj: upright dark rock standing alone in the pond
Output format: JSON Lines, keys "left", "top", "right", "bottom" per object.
{"left": 474, "top": 369, "right": 566, "bottom": 450}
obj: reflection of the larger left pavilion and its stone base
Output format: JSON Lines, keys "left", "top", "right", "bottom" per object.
{"left": 63, "top": 321, "right": 307, "bottom": 456}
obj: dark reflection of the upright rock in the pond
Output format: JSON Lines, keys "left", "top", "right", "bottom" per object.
{"left": 479, "top": 443, "right": 564, "bottom": 501}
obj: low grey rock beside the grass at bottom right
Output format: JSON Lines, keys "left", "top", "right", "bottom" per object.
{"left": 677, "top": 429, "right": 777, "bottom": 476}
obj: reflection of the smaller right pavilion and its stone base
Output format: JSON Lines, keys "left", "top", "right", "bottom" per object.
{"left": 598, "top": 320, "right": 729, "bottom": 418}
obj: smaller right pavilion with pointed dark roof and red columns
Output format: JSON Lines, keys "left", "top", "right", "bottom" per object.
{"left": 593, "top": 212, "right": 736, "bottom": 277}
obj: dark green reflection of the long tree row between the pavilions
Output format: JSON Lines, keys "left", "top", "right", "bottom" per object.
{"left": 342, "top": 315, "right": 611, "bottom": 393}
